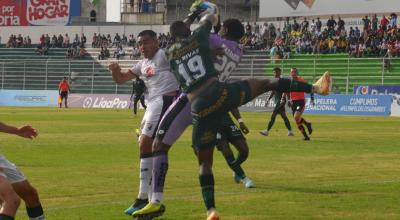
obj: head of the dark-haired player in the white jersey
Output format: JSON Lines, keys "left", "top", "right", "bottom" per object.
{"left": 137, "top": 30, "right": 158, "bottom": 58}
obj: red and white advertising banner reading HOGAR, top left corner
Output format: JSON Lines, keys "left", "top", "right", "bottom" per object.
{"left": 0, "top": 0, "right": 71, "bottom": 26}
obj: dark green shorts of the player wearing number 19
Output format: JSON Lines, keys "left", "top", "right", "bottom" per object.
{"left": 191, "top": 81, "right": 251, "bottom": 149}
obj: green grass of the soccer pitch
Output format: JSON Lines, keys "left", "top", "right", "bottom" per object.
{"left": 0, "top": 107, "right": 400, "bottom": 220}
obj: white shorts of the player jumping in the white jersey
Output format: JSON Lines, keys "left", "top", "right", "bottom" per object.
{"left": 140, "top": 96, "right": 175, "bottom": 138}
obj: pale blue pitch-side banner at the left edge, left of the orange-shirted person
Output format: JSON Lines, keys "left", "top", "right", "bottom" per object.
{"left": 0, "top": 90, "right": 58, "bottom": 107}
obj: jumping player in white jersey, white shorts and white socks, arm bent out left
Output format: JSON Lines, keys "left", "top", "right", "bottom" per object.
{"left": 109, "top": 30, "right": 179, "bottom": 215}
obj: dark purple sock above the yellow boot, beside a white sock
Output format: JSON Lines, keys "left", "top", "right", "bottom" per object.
{"left": 151, "top": 151, "right": 168, "bottom": 203}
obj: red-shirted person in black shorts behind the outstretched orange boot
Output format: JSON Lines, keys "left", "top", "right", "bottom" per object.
{"left": 290, "top": 68, "right": 314, "bottom": 141}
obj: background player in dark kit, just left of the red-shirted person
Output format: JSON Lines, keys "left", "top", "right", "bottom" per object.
{"left": 260, "top": 67, "right": 294, "bottom": 136}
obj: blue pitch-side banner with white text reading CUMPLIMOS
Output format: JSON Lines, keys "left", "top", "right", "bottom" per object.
{"left": 305, "top": 95, "right": 392, "bottom": 116}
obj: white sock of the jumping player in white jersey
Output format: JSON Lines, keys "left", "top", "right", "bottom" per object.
{"left": 138, "top": 154, "right": 153, "bottom": 199}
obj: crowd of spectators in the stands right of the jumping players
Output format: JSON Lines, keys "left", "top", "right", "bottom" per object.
{"left": 242, "top": 13, "right": 400, "bottom": 58}
